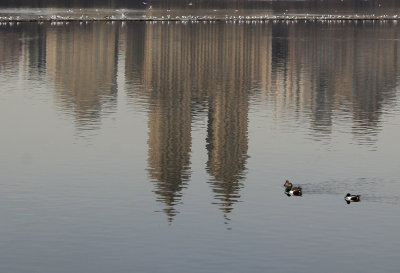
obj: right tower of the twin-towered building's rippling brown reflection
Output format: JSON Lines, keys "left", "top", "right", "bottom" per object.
{"left": 202, "top": 24, "right": 270, "bottom": 219}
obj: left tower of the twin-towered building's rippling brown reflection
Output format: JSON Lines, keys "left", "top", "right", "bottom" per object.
{"left": 126, "top": 21, "right": 192, "bottom": 221}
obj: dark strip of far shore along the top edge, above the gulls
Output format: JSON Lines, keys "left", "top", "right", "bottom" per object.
{"left": 0, "top": 0, "right": 400, "bottom": 12}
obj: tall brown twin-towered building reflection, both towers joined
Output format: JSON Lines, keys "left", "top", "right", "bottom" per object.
{"left": 126, "top": 23, "right": 276, "bottom": 220}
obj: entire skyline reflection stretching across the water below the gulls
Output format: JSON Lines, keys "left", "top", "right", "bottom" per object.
{"left": 0, "top": 22, "right": 400, "bottom": 221}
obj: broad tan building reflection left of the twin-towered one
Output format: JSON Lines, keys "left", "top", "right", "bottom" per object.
{"left": 46, "top": 23, "right": 118, "bottom": 130}
